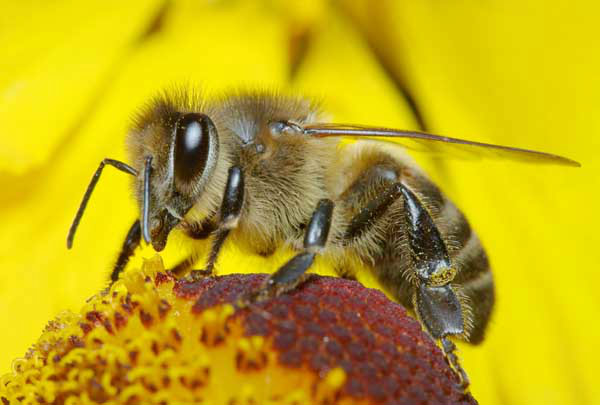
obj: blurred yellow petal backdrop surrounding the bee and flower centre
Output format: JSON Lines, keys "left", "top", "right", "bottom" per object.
{"left": 0, "top": 0, "right": 600, "bottom": 404}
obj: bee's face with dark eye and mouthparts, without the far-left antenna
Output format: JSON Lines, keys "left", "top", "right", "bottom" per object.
{"left": 133, "top": 112, "right": 219, "bottom": 251}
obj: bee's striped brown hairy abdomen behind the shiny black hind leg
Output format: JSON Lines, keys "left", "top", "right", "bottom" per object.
{"left": 340, "top": 144, "right": 494, "bottom": 343}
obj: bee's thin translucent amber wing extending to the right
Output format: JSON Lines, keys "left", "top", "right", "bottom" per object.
{"left": 303, "top": 123, "right": 581, "bottom": 167}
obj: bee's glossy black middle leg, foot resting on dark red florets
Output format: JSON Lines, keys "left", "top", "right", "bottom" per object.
{"left": 249, "top": 199, "right": 334, "bottom": 301}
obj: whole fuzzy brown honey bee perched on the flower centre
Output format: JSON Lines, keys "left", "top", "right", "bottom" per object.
{"left": 67, "top": 91, "right": 579, "bottom": 388}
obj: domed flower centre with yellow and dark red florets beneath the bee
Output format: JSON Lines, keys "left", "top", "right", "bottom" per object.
{"left": 0, "top": 256, "right": 476, "bottom": 405}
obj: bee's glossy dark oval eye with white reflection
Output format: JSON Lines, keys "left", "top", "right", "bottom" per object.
{"left": 175, "top": 113, "right": 216, "bottom": 182}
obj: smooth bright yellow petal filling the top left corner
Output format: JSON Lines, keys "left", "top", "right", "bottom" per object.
{"left": 0, "top": 0, "right": 164, "bottom": 175}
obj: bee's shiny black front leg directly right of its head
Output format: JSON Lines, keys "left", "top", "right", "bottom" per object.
{"left": 205, "top": 166, "right": 244, "bottom": 274}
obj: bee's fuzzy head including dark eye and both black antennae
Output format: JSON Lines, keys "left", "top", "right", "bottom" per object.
{"left": 67, "top": 92, "right": 219, "bottom": 251}
